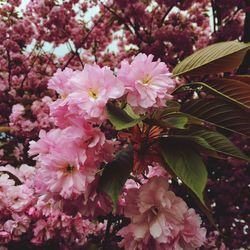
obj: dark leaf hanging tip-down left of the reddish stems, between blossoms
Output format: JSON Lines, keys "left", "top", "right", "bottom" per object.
{"left": 98, "top": 148, "right": 133, "bottom": 210}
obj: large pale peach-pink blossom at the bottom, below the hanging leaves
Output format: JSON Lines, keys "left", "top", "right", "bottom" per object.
{"left": 118, "top": 177, "right": 205, "bottom": 250}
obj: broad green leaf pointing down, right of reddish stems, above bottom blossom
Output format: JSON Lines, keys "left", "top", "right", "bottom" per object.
{"left": 160, "top": 138, "right": 207, "bottom": 206}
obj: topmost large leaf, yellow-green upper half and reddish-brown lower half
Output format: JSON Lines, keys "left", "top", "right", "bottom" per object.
{"left": 173, "top": 41, "right": 250, "bottom": 76}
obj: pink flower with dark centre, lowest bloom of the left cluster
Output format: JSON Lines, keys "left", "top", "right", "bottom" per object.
{"left": 36, "top": 144, "right": 96, "bottom": 199}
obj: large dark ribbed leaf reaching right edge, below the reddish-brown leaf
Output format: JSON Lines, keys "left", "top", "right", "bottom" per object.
{"left": 181, "top": 98, "right": 250, "bottom": 137}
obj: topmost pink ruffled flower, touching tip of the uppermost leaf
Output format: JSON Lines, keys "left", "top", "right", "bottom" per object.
{"left": 118, "top": 53, "right": 175, "bottom": 109}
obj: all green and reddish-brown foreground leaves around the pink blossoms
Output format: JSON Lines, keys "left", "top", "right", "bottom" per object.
{"left": 100, "top": 41, "right": 250, "bottom": 221}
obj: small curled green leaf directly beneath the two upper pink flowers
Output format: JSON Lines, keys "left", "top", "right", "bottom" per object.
{"left": 106, "top": 103, "right": 146, "bottom": 130}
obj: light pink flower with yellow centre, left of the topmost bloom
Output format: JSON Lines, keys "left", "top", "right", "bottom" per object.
{"left": 69, "top": 65, "right": 124, "bottom": 120}
